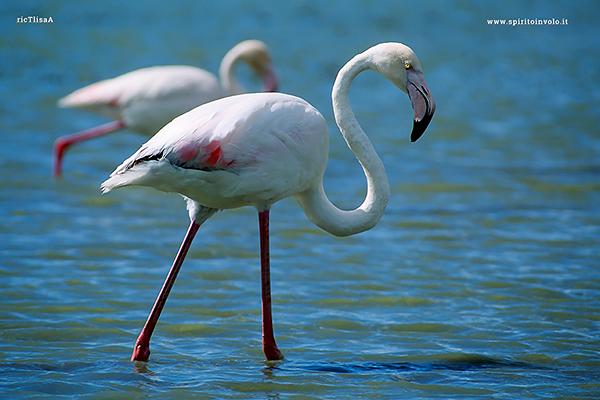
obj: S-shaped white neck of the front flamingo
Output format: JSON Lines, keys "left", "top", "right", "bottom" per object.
{"left": 296, "top": 54, "right": 390, "bottom": 236}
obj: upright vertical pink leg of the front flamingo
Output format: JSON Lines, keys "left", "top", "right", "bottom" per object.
{"left": 258, "top": 210, "right": 283, "bottom": 361}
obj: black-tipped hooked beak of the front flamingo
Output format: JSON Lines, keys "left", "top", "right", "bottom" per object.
{"left": 406, "top": 68, "right": 435, "bottom": 142}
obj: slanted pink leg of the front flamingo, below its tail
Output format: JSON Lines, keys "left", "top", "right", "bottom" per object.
{"left": 131, "top": 221, "right": 200, "bottom": 361}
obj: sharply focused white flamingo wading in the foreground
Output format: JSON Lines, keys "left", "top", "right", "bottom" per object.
{"left": 101, "top": 43, "right": 435, "bottom": 361}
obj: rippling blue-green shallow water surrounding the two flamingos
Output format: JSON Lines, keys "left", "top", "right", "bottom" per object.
{"left": 0, "top": 1, "right": 600, "bottom": 399}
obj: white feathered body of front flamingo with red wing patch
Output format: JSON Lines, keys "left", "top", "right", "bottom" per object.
{"left": 102, "top": 93, "right": 329, "bottom": 210}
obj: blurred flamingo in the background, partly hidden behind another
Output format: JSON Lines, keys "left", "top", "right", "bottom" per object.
{"left": 53, "top": 40, "right": 278, "bottom": 176}
